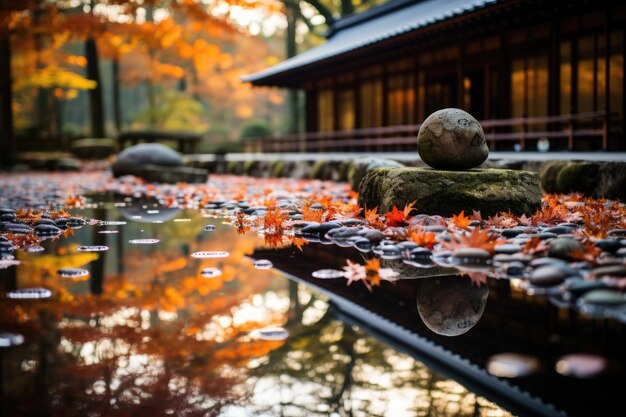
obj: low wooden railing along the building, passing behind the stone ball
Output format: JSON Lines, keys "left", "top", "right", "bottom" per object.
{"left": 244, "top": 111, "right": 610, "bottom": 153}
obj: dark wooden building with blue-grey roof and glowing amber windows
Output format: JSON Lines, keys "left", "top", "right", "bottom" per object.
{"left": 246, "top": 0, "right": 626, "bottom": 151}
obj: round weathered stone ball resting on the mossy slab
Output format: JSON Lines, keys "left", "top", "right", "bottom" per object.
{"left": 417, "top": 108, "right": 489, "bottom": 170}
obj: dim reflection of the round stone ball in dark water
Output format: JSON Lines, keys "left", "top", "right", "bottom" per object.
{"left": 417, "top": 275, "right": 489, "bottom": 336}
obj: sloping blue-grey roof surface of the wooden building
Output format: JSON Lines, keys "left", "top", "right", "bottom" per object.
{"left": 242, "top": 0, "right": 503, "bottom": 85}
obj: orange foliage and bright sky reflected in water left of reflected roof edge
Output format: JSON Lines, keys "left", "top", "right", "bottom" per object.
{"left": 0, "top": 202, "right": 506, "bottom": 416}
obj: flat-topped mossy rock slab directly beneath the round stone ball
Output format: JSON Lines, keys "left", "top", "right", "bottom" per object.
{"left": 359, "top": 168, "right": 541, "bottom": 217}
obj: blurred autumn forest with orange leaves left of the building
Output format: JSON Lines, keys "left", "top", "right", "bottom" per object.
{"left": 0, "top": 0, "right": 383, "bottom": 152}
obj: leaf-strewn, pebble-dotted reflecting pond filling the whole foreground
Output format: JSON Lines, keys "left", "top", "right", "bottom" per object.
{"left": 0, "top": 172, "right": 626, "bottom": 416}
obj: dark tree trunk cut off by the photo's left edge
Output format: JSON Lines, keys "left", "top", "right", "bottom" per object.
{"left": 0, "top": 34, "right": 16, "bottom": 166}
